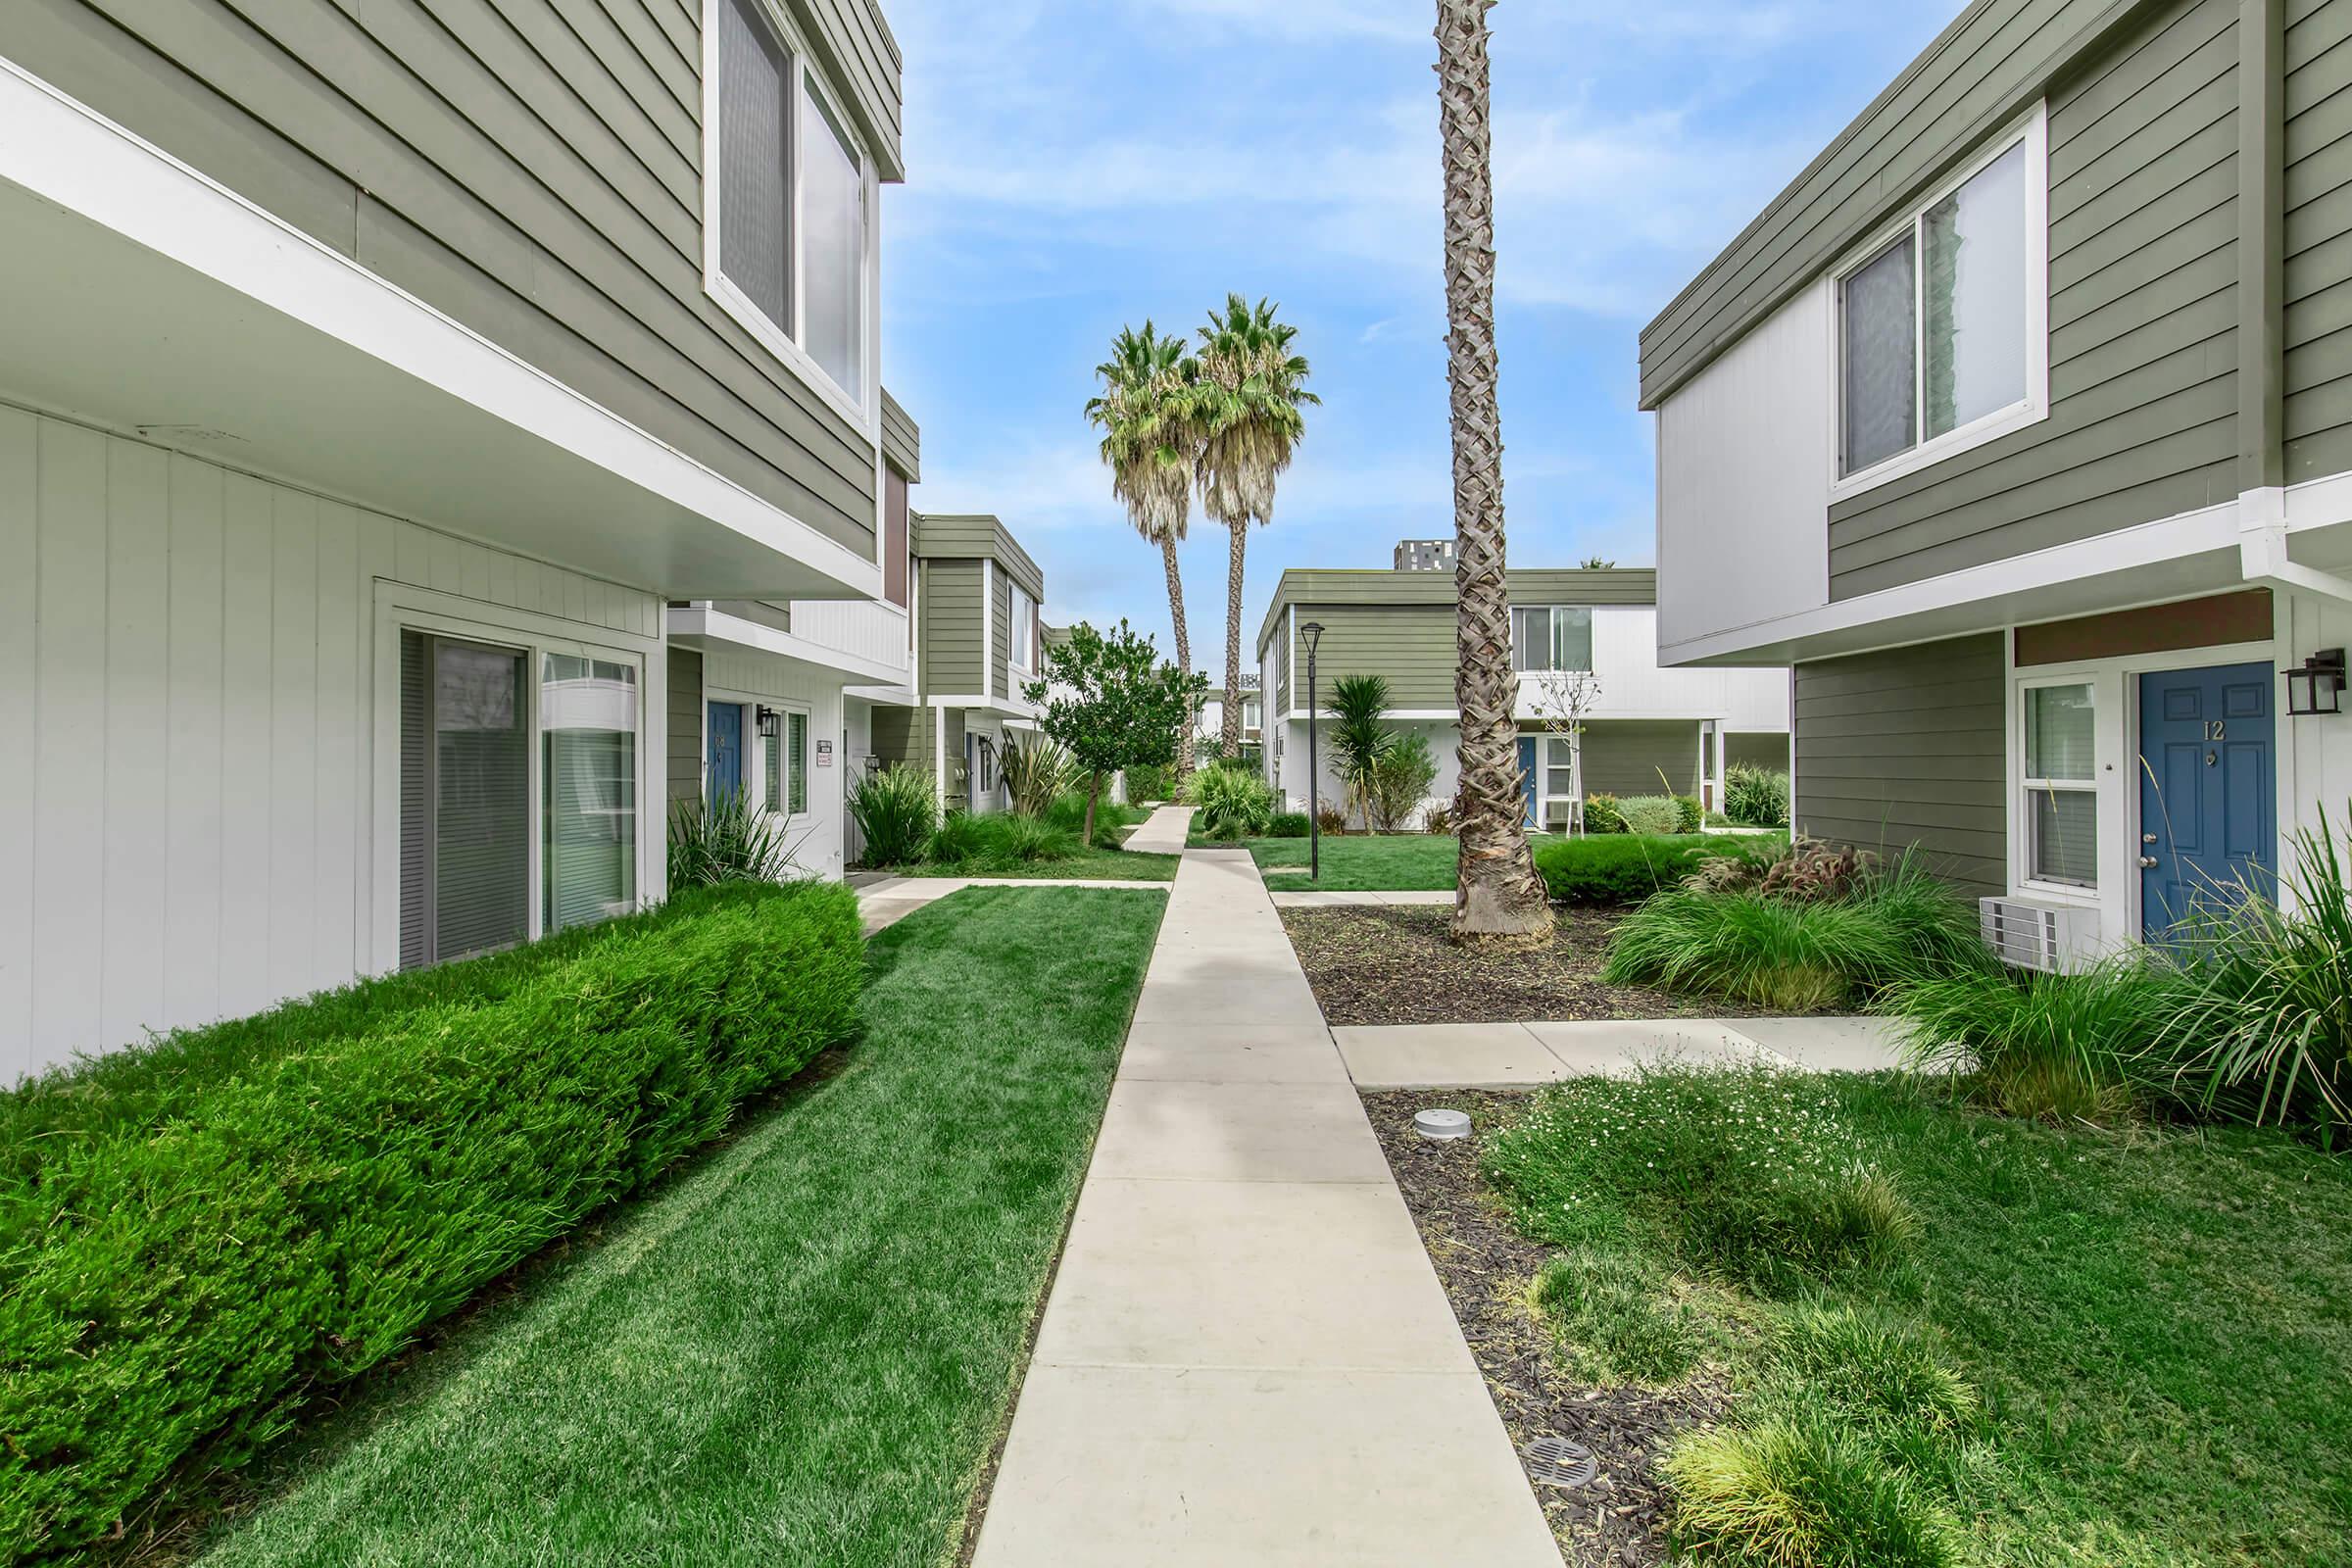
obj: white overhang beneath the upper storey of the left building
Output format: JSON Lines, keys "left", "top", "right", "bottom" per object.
{"left": 0, "top": 59, "right": 882, "bottom": 600}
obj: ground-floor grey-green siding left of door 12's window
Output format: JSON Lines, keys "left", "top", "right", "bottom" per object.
{"left": 1794, "top": 632, "right": 2009, "bottom": 894}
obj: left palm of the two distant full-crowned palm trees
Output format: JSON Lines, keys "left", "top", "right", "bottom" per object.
{"left": 1087, "top": 319, "right": 1204, "bottom": 778}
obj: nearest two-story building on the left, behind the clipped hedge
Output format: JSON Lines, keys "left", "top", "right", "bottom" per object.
{"left": 0, "top": 0, "right": 901, "bottom": 1077}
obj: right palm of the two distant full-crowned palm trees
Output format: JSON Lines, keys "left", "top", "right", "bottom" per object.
{"left": 1195, "top": 294, "right": 1322, "bottom": 757}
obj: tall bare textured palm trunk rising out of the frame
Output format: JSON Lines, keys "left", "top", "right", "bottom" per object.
{"left": 1437, "top": 0, "right": 1552, "bottom": 938}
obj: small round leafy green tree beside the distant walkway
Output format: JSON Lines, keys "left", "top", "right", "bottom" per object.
{"left": 1023, "top": 618, "right": 1209, "bottom": 844}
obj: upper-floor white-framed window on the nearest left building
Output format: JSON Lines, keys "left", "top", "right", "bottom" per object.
{"left": 704, "top": 0, "right": 872, "bottom": 418}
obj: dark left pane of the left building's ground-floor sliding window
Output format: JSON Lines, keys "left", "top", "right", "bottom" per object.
{"left": 400, "top": 632, "right": 531, "bottom": 968}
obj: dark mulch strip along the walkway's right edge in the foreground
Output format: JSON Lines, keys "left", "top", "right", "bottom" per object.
{"left": 1354, "top": 1091, "right": 1724, "bottom": 1568}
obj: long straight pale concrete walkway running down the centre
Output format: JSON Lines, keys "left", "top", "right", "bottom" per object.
{"left": 974, "top": 851, "right": 1559, "bottom": 1568}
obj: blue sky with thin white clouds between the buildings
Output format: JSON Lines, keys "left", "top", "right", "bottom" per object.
{"left": 882, "top": 0, "right": 1959, "bottom": 670}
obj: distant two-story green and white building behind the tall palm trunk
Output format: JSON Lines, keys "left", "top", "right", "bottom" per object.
{"left": 1258, "top": 548, "right": 1789, "bottom": 827}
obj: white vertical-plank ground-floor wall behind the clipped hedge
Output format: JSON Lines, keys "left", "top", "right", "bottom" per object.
{"left": 0, "top": 407, "right": 662, "bottom": 1081}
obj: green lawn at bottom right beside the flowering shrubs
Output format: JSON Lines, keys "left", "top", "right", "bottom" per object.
{"left": 1477, "top": 1077, "right": 2352, "bottom": 1568}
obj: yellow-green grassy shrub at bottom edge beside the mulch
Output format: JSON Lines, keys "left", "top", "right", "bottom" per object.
{"left": 1660, "top": 1405, "right": 1969, "bottom": 1568}
